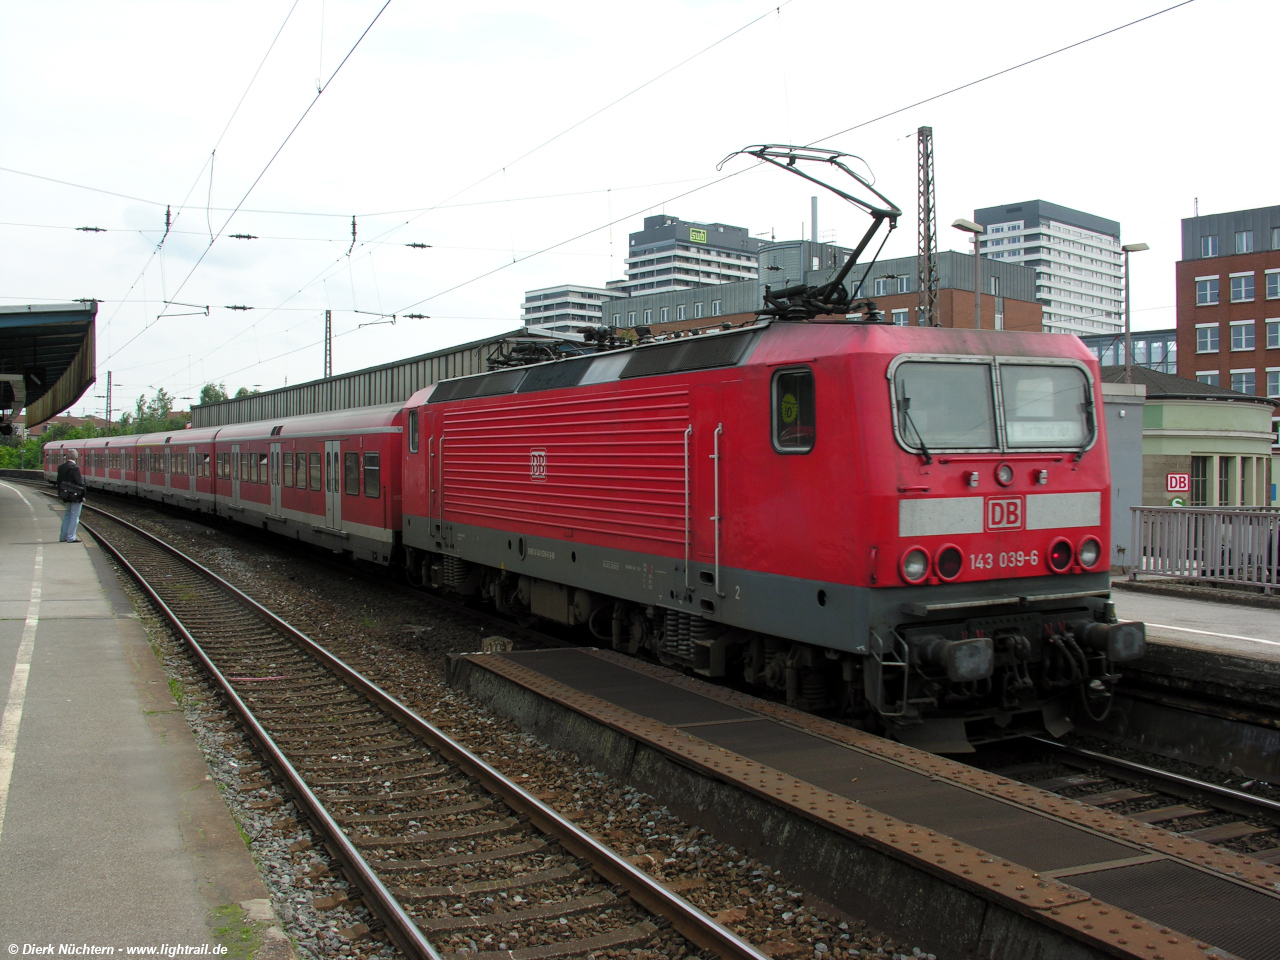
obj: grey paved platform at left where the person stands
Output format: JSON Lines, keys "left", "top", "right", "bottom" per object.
{"left": 0, "top": 480, "right": 275, "bottom": 956}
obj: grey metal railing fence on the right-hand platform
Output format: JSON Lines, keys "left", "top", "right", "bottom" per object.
{"left": 1128, "top": 507, "right": 1280, "bottom": 594}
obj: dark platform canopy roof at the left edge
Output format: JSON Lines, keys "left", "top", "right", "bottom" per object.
{"left": 0, "top": 300, "right": 97, "bottom": 429}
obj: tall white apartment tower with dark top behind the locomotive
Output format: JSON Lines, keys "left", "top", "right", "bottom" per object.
{"left": 974, "top": 200, "right": 1124, "bottom": 337}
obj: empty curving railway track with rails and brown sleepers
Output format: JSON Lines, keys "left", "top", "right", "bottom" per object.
{"left": 83, "top": 507, "right": 765, "bottom": 960}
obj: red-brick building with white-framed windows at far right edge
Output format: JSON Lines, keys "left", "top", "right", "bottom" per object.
{"left": 1176, "top": 206, "right": 1280, "bottom": 419}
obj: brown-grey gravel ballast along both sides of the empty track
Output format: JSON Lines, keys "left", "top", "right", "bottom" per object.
{"left": 92, "top": 502, "right": 934, "bottom": 960}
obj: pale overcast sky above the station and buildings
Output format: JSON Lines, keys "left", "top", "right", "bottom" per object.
{"left": 0, "top": 0, "right": 1280, "bottom": 412}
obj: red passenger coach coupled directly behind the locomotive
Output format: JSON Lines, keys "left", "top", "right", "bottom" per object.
{"left": 214, "top": 404, "right": 404, "bottom": 563}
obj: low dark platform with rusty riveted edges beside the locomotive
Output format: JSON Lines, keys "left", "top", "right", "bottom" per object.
{"left": 451, "top": 648, "right": 1280, "bottom": 960}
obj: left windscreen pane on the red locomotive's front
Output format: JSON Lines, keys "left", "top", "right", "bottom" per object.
{"left": 893, "top": 361, "right": 997, "bottom": 452}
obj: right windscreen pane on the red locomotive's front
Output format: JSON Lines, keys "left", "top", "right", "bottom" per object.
{"left": 1000, "top": 364, "right": 1093, "bottom": 448}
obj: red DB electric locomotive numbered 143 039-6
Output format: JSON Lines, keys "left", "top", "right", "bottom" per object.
{"left": 403, "top": 320, "right": 1143, "bottom": 749}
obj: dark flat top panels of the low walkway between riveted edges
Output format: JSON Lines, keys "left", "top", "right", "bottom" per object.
{"left": 477, "top": 649, "right": 1280, "bottom": 960}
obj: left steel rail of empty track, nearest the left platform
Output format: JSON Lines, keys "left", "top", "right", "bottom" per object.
{"left": 83, "top": 519, "right": 442, "bottom": 960}
